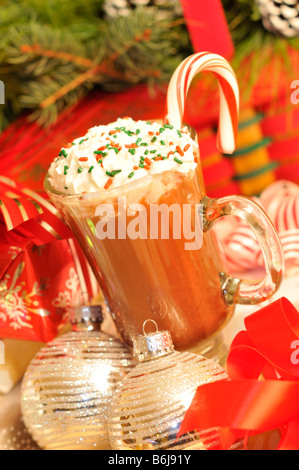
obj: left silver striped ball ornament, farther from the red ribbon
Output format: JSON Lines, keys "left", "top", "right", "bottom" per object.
{"left": 21, "top": 306, "right": 136, "bottom": 450}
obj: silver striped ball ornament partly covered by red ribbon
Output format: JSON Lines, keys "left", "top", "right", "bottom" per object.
{"left": 108, "top": 322, "right": 228, "bottom": 450}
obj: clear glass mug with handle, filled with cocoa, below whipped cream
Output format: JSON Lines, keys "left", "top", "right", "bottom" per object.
{"left": 45, "top": 124, "right": 283, "bottom": 359}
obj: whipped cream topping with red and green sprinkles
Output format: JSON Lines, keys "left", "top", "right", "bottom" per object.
{"left": 49, "top": 118, "right": 197, "bottom": 194}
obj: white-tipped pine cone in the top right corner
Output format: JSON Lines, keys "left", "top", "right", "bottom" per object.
{"left": 256, "top": 0, "right": 299, "bottom": 38}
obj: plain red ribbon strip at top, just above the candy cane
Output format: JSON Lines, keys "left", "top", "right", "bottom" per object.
{"left": 181, "top": 0, "right": 234, "bottom": 58}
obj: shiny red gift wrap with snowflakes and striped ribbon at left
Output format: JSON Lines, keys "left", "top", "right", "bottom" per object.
{"left": 0, "top": 177, "right": 98, "bottom": 343}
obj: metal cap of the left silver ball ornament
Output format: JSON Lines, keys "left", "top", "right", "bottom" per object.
{"left": 70, "top": 305, "right": 104, "bottom": 331}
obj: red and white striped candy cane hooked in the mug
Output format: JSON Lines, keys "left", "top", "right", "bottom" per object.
{"left": 165, "top": 52, "right": 239, "bottom": 154}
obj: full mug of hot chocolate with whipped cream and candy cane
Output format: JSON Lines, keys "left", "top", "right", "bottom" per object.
{"left": 46, "top": 52, "right": 283, "bottom": 360}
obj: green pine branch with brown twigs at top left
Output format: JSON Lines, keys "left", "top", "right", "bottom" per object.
{"left": 0, "top": 0, "right": 191, "bottom": 130}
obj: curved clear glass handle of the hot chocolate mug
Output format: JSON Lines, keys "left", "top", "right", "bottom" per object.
{"left": 201, "top": 196, "right": 284, "bottom": 305}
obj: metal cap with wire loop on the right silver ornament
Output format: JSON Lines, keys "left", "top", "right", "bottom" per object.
{"left": 133, "top": 320, "right": 174, "bottom": 362}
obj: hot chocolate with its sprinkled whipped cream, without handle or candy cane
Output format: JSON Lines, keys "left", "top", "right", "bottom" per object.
{"left": 49, "top": 119, "right": 232, "bottom": 349}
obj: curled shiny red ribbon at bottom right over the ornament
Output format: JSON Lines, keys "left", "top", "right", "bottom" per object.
{"left": 180, "top": 298, "right": 299, "bottom": 450}
